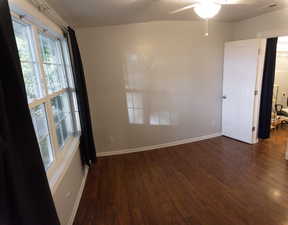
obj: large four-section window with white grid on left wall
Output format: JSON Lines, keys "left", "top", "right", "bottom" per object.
{"left": 13, "top": 19, "right": 80, "bottom": 171}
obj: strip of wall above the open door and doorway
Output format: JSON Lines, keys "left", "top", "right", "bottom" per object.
{"left": 233, "top": 8, "right": 288, "bottom": 40}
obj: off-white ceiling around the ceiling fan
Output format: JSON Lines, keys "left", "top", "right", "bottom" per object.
{"left": 47, "top": 0, "right": 288, "bottom": 27}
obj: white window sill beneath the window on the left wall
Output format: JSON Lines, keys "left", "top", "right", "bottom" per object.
{"left": 48, "top": 135, "right": 80, "bottom": 195}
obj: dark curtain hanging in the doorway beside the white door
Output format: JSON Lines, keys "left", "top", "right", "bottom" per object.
{"left": 258, "top": 38, "right": 278, "bottom": 139}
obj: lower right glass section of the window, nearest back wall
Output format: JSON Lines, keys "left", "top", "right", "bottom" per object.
{"left": 51, "top": 93, "right": 73, "bottom": 147}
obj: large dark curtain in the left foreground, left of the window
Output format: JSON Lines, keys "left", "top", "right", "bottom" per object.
{"left": 0, "top": 0, "right": 60, "bottom": 225}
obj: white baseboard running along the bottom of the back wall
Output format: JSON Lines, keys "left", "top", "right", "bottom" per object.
{"left": 97, "top": 132, "right": 222, "bottom": 157}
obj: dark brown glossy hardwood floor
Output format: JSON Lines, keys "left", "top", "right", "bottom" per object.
{"left": 74, "top": 129, "right": 288, "bottom": 225}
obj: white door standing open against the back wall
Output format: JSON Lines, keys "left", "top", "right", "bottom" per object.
{"left": 222, "top": 39, "right": 265, "bottom": 144}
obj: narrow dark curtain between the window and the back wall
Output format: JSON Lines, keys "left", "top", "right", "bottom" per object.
{"left": 68, "top": 27, "right": 96, "bottom": 166}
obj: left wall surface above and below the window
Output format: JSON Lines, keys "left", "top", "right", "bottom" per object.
{"left": 9, "top": 0, "right": 87, "bottom": 225}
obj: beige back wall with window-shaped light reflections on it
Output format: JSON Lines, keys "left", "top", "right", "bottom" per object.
{"left": 76, "top": 21, "right": 231, "bottom": 152}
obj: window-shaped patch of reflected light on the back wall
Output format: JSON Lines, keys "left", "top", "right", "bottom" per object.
{"left": 123, "top": 50, "right": 178, "bottom": 126}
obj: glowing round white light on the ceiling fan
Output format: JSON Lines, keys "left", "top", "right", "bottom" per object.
{"left": 194, "top": 1, "right": 221, "bottom": 19}
